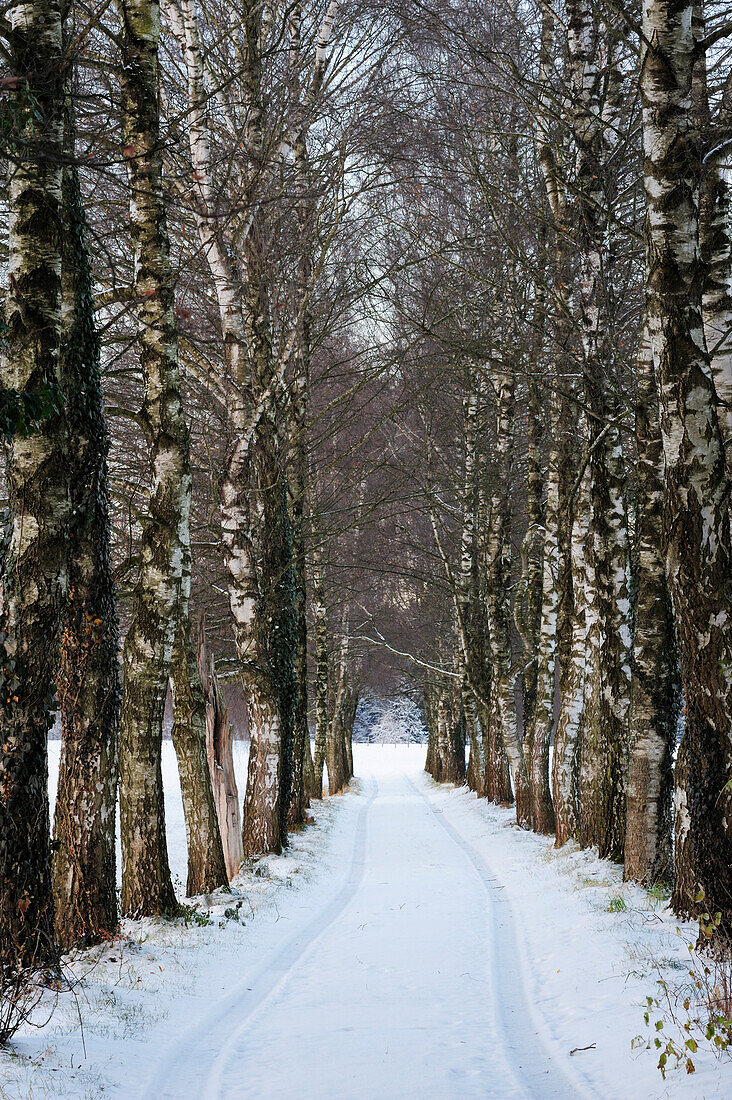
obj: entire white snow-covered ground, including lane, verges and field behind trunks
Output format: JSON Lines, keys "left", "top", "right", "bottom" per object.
{"left": 0, "top": 743, "right": 732, "bottom": 1100}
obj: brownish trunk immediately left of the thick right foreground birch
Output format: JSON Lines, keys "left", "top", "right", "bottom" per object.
{"left": 624, "top": 328, "right": 681, "bottom": 886}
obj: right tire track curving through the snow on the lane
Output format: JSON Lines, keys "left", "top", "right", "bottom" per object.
{"left": 404, "top": 773, "right": 597, "bottom": 1100}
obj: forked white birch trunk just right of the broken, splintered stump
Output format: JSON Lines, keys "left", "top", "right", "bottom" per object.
{"left": 170, "top": 0, "right": 297, "bottom": 856}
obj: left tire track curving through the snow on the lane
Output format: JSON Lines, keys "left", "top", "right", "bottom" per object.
{"left": 141, "top": 779, "right": 379, "bottom": 1100}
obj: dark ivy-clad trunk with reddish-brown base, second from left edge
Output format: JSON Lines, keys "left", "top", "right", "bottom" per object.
{"left": 53, "top": 99, "right": 121, "bottom": 950}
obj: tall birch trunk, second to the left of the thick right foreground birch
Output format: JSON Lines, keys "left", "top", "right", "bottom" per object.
{"left": 567, "top": 0, "right": 630, "bottom": 859}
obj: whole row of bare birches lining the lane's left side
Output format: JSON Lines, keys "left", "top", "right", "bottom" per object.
{"left": 0, "top": 0, "right": 362, "bottom": 972}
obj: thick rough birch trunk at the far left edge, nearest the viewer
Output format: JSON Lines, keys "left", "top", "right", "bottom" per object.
{"left": 0, "top": 0, "right": 69, "bottom": 969}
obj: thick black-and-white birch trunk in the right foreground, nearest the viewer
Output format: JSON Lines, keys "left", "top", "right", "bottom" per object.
{"left": 641, "top": 0, "right": 732, "bottom": 935}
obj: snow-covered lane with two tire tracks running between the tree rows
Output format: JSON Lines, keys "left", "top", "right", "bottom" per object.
{"left": 145, "top": 773, "right": 586, "bottom": 1100}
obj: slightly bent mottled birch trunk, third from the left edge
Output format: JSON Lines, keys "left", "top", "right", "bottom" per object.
{"left": 115, "top": 0, "right": 190, "bottom": 916}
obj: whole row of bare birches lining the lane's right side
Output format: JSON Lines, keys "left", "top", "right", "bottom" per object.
{"left": 407, "top": 0, "right": 732, "bottom": 936}
